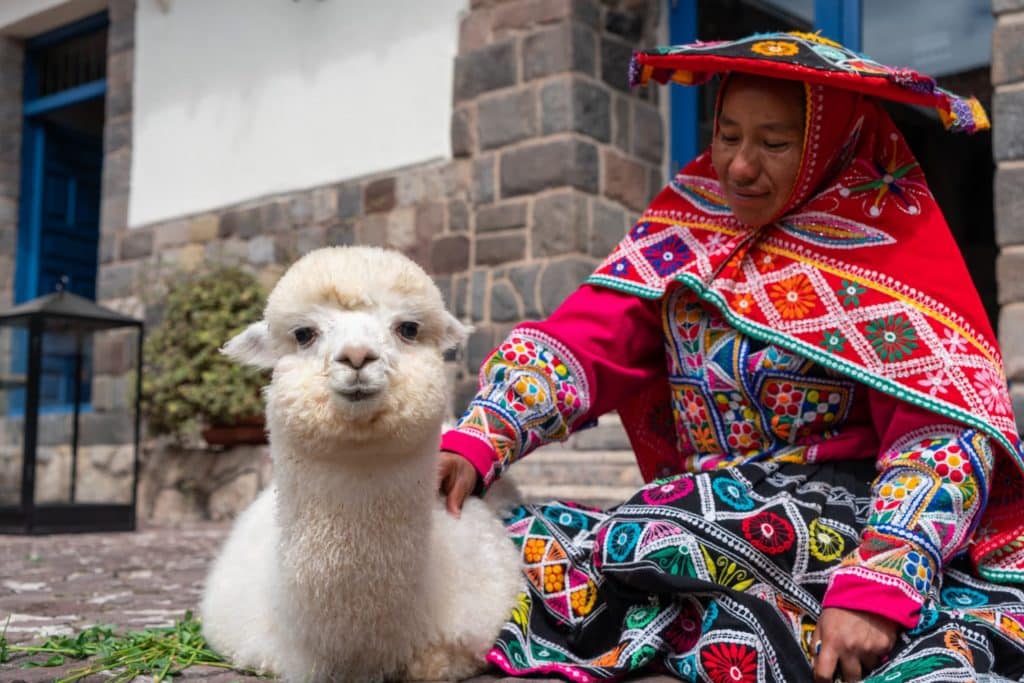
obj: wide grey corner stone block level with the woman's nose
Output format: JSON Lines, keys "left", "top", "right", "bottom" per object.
{"left": 501, "top": 139, "right": 598, "bottom": 198}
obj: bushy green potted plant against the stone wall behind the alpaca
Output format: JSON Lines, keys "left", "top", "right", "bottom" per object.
{"left": 142, "top": 265, "right": 266, "bottom": 445}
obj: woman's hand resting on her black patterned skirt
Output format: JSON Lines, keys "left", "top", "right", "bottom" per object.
{"left": 811, "top": 607, "right": 899, "bottom": 683}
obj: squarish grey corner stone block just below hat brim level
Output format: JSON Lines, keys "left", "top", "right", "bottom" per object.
{"left": 541, "top": 78, "right": 611, "bottom": 142}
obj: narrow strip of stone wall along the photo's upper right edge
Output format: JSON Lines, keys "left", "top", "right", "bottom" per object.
{"left": 992, "top": 0, "right": 1024, "bottom": 432}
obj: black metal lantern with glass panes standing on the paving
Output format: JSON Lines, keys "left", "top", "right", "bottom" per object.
{"left": 0, "top": 291, "right": 142, "bottom": 533}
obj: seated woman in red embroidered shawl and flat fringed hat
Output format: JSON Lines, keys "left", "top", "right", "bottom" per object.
{"left": 441, "top": 34, "right": 1024, "bottom": 681}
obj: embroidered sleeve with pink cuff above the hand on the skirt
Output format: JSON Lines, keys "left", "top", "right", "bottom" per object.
{"left": 822, "top": 390, "right": 993, "bottom": 628}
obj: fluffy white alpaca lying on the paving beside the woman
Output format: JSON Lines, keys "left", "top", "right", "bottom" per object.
{"left": 201, "top": 247, "right": 520, "bottom": 681}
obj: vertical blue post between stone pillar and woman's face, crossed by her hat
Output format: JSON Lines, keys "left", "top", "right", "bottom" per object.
{"left": 669, "top": 0, "right": 700, "bottom": 178}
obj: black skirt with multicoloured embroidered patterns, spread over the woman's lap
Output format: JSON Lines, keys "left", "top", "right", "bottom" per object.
{"left": 488, "top": 461, "right": 1024, "bottom": 683}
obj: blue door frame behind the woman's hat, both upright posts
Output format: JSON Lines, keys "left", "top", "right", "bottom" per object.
{"left": 668, "top": 0, "right": 862, "bottom": 174}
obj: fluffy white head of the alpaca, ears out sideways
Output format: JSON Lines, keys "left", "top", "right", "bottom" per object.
{"left": 223, "top": 247, "right": 466, "bottom": 458}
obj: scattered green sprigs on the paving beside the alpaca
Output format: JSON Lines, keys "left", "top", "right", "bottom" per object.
{"left": 0, "top": 611, "right": 266, "bottom": 683}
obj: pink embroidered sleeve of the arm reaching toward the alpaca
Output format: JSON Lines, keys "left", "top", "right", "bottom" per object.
{"left": 441, "top": 285, "right": 665, "bottom": 485}
